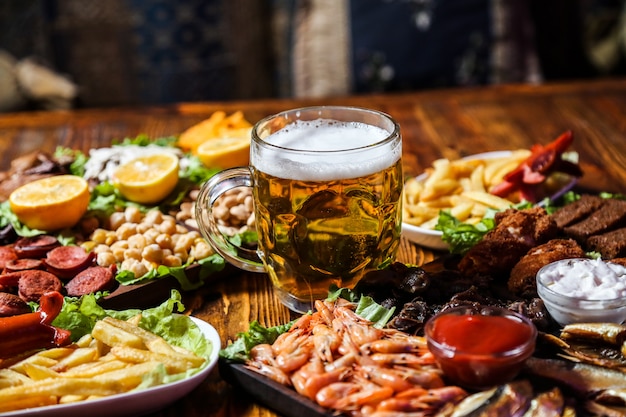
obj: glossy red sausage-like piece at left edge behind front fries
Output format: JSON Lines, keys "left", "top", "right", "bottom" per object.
{"left": 0, "top": 291, "right": 71, "bottom": 358}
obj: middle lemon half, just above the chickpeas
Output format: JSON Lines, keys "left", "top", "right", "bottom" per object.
{"left": 113, "top": 152, "right": 178, "bottom": 204}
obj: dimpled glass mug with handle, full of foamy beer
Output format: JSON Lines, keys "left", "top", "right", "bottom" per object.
{"left": 196, "top": 106, "right": 403, "bottom": 312}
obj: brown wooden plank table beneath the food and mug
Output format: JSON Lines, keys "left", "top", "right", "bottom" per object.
{"left": 0, "top": 79, "right": 626, "bottom": 417}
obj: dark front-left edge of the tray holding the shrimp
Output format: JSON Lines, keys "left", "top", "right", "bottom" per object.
{"left": 218, "top": 358, "right": 338, "bottom": 417}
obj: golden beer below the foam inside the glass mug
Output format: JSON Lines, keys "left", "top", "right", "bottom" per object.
{"left": 254, "top": 160, "right": 402, "bottom": 305}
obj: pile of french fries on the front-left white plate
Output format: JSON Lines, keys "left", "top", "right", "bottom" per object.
{"left": 0, "top": 316, "right": 205, "bottom": 412}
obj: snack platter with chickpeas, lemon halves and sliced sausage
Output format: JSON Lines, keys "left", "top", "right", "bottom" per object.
{"left": 0, "top": 112, "right": 255, "bottom": 309}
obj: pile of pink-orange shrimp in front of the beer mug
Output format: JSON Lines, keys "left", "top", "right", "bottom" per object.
{"left": 246, "top": 300, "right": 468, "bottom": 417}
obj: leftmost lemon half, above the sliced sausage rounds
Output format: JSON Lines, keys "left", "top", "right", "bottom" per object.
{"left": 9, "top": 175, "right": 90, "bottom": 231}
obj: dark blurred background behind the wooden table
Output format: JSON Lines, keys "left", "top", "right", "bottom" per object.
{"left": 0, "top": 0, "right": 626, "bottom": 111}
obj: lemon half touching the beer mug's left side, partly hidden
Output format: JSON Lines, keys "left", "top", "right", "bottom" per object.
{"left": 197, "top": 137, "right": 250, "bottom": 169}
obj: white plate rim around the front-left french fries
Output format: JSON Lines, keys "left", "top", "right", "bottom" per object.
{"left": 0, "top": 317, "right": 221, "bottom": 417}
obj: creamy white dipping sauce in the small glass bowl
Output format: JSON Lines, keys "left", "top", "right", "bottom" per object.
{"left": 541, "top": 259, "right": 626, "bottom": 300}
